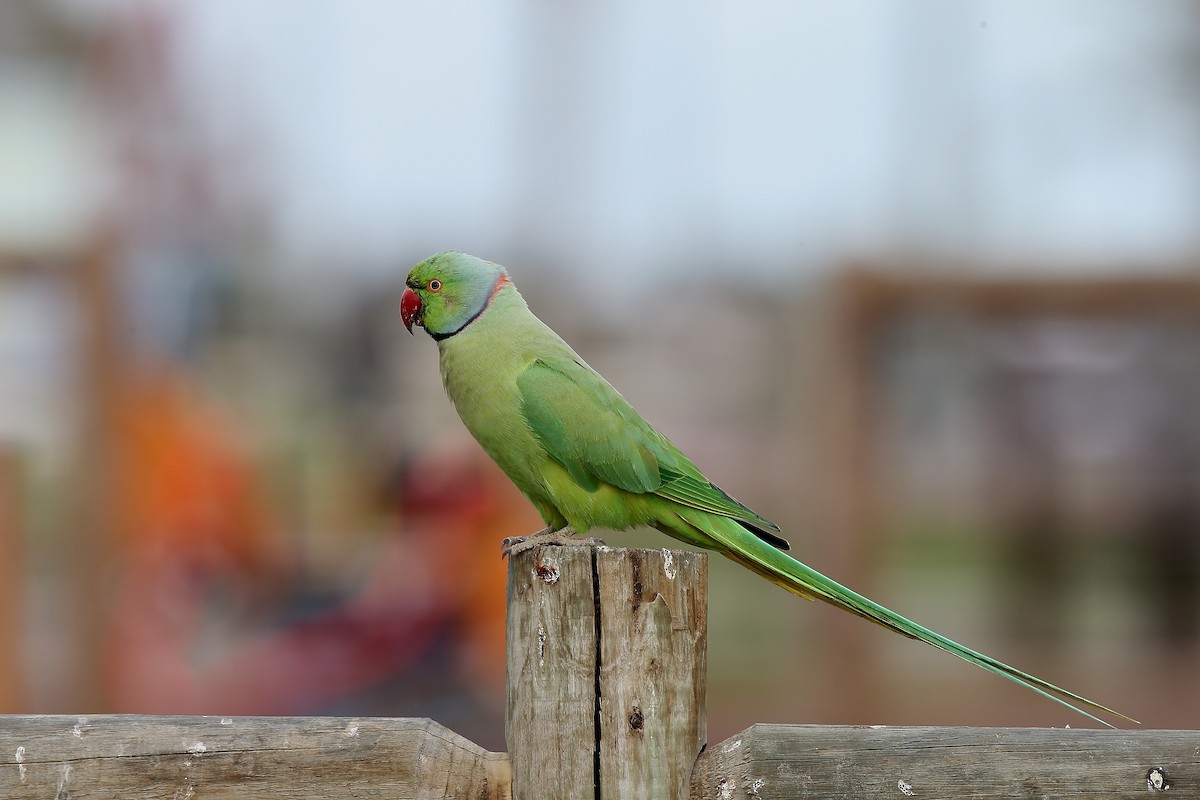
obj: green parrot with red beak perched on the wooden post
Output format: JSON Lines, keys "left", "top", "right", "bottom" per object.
{"left": 400, "top": 252, "right": 1133, "bottom": 727}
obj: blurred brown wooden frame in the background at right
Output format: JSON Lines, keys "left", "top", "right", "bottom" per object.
{"left": 809, "top": 272, "right": 1200, "bottom": 718}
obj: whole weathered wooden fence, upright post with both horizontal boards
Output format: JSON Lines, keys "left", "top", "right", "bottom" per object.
{"left": 0, "top": 547, "right": 1200, "bottom": 800}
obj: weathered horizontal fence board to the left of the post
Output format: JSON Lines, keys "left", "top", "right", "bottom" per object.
{"left": 0, "top": 715, "right": 511, "bottom": 800}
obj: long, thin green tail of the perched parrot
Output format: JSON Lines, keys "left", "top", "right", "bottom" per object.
{"left": 679, "top": 510, "right": 1138, "bottom": 728}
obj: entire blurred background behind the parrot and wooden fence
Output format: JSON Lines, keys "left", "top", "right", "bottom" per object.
{"left": 0, "top": 0, "right": 1200, "bottom": 750}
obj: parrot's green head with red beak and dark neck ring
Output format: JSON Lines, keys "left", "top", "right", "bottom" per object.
{"left": 400, "top": 252, "right": 510, "bottom": 338}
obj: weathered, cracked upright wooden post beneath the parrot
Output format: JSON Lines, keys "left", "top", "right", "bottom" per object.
{"left": 505, "top": 547, "right": 708, "bottom": 800}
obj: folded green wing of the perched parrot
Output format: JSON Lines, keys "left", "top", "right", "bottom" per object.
{"left": 517, "top": 356, "right": 786, "bottom": 537}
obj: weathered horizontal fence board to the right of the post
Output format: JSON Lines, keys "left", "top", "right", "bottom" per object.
{"left": 691, "top": 724, "right": 1200, "bottom": 800}
